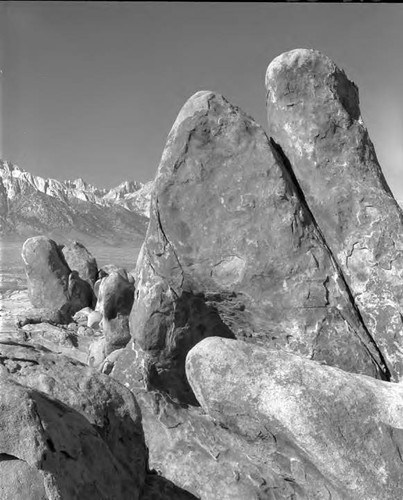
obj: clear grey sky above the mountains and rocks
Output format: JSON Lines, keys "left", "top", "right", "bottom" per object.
{"left": 0, "top": 1, "right": 403, "bottom": 200}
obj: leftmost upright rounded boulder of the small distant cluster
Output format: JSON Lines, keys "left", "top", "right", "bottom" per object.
{"left": 22, "top": 236, "right": 71, "bottom": 309}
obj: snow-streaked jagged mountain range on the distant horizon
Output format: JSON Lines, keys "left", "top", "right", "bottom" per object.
{"left": 0, "top": 160, "right": 153, "bottom": 244}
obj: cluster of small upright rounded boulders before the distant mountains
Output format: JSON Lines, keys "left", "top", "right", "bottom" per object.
{"left": 19, "top": 236, "right": 134, "bottom": 371}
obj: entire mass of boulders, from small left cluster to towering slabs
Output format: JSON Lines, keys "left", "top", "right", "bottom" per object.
{"left": 0, "top": 49, "right": 403, "bottom": 500}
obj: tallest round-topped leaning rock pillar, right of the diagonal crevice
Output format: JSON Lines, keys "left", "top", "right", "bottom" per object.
{"left": 266, "top": 49, "right": 403, "bottom": 379}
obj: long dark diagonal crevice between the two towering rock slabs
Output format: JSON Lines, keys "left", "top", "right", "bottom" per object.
{"left": 270, "top": 138, "right": 391, "bottom": 382}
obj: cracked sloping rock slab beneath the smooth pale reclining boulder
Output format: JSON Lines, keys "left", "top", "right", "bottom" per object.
{"left": 111, "top": 349, "right": 318, "bottom": 500}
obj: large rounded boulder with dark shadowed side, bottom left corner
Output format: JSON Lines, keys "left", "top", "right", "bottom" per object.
{"left": 0, "top": 343, "right": 147, "bottom": 500}
